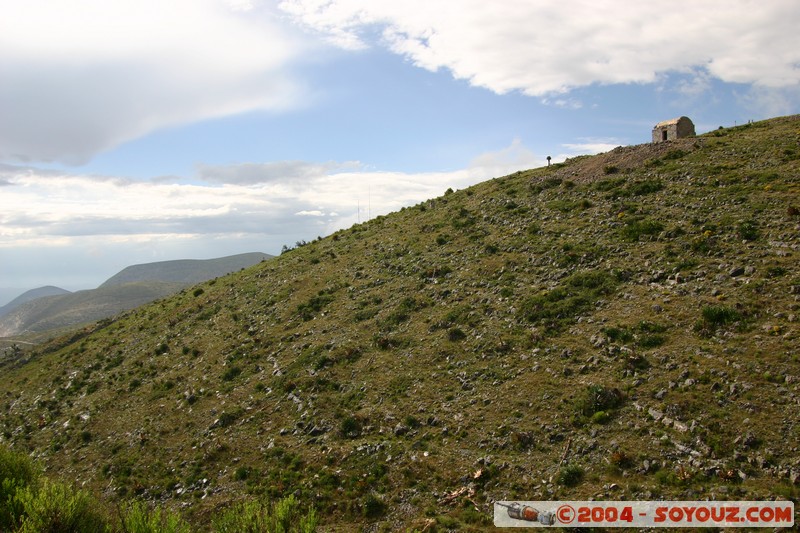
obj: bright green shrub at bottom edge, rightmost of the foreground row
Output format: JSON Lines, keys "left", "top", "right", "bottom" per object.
{"left": 212, "top": 496, "right": 319, "bottom": 533}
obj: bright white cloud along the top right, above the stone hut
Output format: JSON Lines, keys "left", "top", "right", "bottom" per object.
{"left": 280, "top": 0, "right": 800, "bottom": 96}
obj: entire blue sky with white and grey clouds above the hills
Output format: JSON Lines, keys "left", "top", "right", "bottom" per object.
{"left": 0, "top": 0, "right": 800, "bottom": 304}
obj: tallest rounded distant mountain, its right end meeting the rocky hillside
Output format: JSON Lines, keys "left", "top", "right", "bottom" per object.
{"left": 100, "top": 252, "right": 273, "bottom": 287}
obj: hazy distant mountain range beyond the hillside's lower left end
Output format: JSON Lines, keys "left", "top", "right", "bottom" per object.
{"left": 0, "top": 253, "right": 272, "bottom": 337}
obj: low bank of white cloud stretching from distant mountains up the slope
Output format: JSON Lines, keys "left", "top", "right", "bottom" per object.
{"left": 0, "top": 140, "right": 564, "bottom": 290}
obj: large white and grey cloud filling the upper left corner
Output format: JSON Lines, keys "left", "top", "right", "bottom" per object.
{"left": 0, "top": 0, "right": 304, "bottom": 163}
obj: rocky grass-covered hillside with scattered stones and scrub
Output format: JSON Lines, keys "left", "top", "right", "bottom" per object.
{"left": 0, "top": 116, "right": 800, "bottom": 531}
